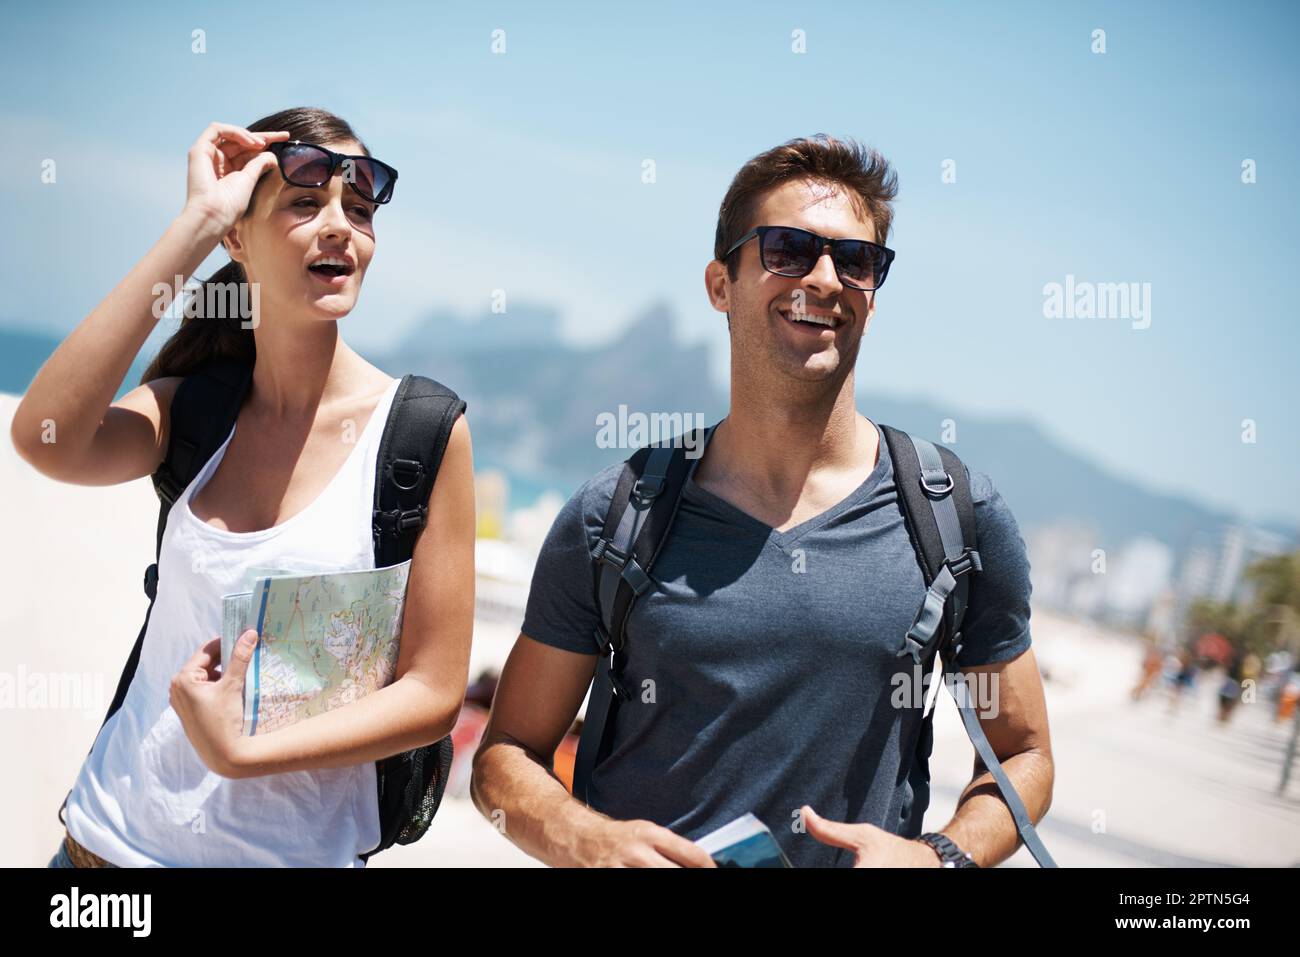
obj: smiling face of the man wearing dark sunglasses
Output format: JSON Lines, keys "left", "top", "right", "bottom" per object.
{"left": 706, "top": 179, "right": 876, "bottom": 381}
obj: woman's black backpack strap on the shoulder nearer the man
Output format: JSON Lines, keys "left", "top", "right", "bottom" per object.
{"left": 372, "top": 374, "right": 465, "bottom": 568}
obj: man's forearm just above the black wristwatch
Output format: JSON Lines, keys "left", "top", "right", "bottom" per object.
{"left": 941, "top": 750, "right": 1056, "bottom": 867}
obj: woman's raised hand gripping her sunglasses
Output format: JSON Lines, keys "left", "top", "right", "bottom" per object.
{"left": 185, "top": 124, "right": 289, "bottom": 233}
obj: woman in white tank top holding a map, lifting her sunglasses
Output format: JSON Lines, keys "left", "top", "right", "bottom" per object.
{"left": 12, "top": 109, "right": 475, "bottom": 867}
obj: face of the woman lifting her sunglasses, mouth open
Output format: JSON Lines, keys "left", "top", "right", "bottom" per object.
{"left": 226, "top": 140, "right": 378, "bottom": 319}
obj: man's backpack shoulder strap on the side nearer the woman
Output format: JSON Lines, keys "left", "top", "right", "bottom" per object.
{"left": 573, "top": 425, "right": 716, "bottom": 802}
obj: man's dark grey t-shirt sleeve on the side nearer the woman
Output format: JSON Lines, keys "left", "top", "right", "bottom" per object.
{"left": 523, "top": 463, "right": 623, "bottom": 654}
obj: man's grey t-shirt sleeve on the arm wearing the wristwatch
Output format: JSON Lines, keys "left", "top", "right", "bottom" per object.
{"left": 957, "top": 469, "right": 1032, "bottom": 667}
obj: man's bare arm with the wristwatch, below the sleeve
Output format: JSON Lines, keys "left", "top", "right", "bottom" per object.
{"left": 940, "top": 649, "right": 1056, "bottom": 867}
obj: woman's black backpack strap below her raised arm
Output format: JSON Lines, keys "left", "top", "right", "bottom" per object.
{"left": 59, "top": 359, "right": 252, "bottom": 823}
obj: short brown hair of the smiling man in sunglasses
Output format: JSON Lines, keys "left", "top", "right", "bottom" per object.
{"left": 714, "top": 133, "right": 898, "bottom": 280}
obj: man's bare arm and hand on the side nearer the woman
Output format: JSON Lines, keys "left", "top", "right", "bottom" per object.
{"left": 469, "top": 635, "right": 712, "bottom": 867}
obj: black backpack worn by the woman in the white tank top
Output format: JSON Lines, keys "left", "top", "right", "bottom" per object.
{"left": 59, "top": 360, "right": 465, "bottom": 861}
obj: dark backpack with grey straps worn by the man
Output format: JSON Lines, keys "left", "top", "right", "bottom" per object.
{"left": 573, "top": 425, "right": 1056, "bottom": 867}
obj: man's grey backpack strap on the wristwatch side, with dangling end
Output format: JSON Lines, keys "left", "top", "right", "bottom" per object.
{"left": 880, "top": 425, "right": 1056, "bottom": 867}
